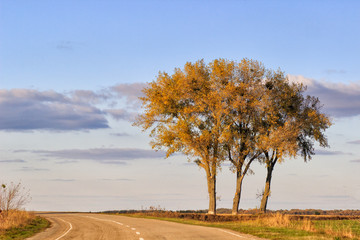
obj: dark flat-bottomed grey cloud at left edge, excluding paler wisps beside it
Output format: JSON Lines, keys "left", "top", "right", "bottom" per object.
{"left": 0, "top": 89, "right": 109, "bottom": 131}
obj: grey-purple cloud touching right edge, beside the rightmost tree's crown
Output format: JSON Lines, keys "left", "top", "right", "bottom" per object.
{"left": 288, "top": 75, "right": 360, "bottom": 117}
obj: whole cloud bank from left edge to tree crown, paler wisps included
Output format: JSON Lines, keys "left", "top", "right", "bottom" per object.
{"left": 0, "top": 83, "right": 146, "bottom": 131}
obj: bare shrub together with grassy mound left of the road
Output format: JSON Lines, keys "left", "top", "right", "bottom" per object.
{"left": 0, "top": 183, "right": 50, "bottom": 240}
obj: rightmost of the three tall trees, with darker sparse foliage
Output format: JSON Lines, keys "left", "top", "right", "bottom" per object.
{"left": 259, "top": 71, "right": 331, "bottom": 212}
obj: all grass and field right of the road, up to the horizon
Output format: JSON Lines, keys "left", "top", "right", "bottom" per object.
{"left": 108, "top": 210, "right": 360, "bottom": 240}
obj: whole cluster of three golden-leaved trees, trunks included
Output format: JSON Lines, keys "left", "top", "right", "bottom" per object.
{"left": 135, "top": 59, "right": 331, "bottom": 214}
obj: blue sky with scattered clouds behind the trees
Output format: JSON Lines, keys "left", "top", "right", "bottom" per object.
{"left": 0, "top": 0, "right": 360, "bottom": 211}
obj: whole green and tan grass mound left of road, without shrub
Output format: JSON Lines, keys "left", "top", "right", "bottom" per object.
{"left": 0, "top": 211, "right": 50, "bottom": 240}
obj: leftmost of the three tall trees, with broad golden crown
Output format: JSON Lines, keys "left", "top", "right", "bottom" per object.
{"left": 135, "top": 59, "right": 232, "bottom": 214}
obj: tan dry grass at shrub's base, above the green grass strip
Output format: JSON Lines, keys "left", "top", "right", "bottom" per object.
{"left": 0, "top": 210, "right": 35, "bottom": 231}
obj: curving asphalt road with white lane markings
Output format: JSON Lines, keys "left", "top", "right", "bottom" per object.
{"left": 28, "top": 213, "right": 259, "bottom": 240}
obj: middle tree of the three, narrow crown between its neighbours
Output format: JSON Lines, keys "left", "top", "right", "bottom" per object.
{"left": 222, "top": 59, "right": 266, "bottom": 215}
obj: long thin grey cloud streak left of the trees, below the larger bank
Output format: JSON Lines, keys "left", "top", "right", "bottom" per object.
{"left": 31, "top": 148, "right": 165, "bottom": 164}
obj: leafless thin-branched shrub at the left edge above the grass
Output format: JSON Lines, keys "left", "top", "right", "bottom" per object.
{"left": 0, "top": 182, "right": 31, "bottom": 213}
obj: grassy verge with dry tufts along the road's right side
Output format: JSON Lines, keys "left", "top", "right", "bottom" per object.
{"left": 119, "top": 213, "right": 360, "bottom": 240}
